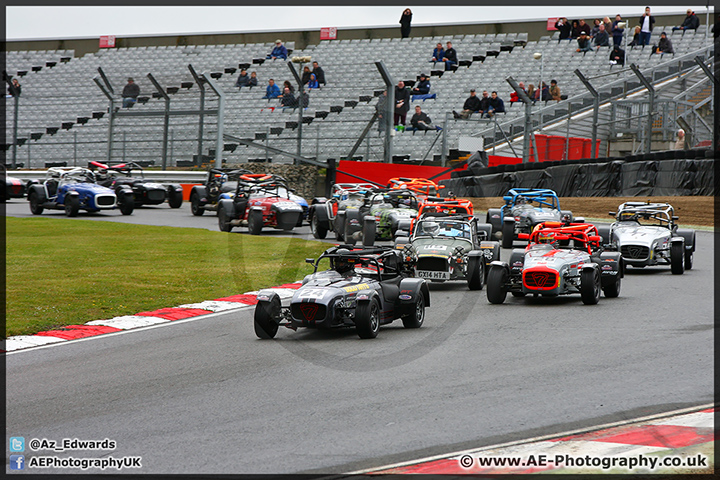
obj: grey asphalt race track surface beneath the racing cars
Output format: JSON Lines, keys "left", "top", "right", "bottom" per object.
{"left": 6, "top": 201, "right": 714, "bottom": 473}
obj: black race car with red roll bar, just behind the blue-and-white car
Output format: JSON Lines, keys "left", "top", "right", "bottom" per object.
{"left": 88, "top": 161, "right": 183, "bottom": 208}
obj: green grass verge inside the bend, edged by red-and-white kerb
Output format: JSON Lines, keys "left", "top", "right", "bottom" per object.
{"left": 5, "top": 217, "right": 328, "bottom": 336}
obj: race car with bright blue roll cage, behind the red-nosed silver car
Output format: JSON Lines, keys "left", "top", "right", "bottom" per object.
{"left": 486, "top": 188, "right": 585, "bottom": 248}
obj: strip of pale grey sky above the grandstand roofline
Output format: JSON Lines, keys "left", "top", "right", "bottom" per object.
{"left": 5, "top": 2, "right": 712, "bottom": 40}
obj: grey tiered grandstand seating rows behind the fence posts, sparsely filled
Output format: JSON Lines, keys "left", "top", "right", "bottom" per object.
{"left": 5, "top": 15, "right": 713, "bottom": 168}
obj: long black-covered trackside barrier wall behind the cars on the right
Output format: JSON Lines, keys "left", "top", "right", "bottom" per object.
{"left": 440, "top": 158, "right": 715, "bottom": 197}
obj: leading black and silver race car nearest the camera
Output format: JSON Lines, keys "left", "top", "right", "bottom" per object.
{"left": 255, "top": 245, "right": 430, "bottom": 338}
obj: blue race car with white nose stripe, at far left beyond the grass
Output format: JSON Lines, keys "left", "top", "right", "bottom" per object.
{"left": 28, "top": 167, "right": 135, "bottom": 217}
